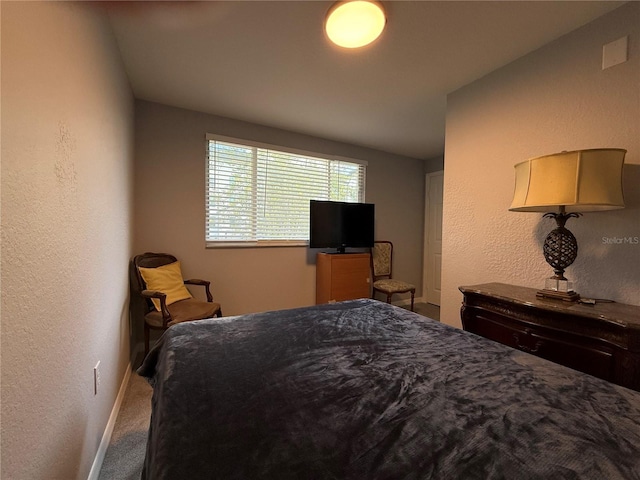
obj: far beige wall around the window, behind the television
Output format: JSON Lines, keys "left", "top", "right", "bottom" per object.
{"left": 135, "top": 101, "right": 424, "bottom": 338}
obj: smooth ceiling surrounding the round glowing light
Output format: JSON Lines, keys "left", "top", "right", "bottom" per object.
{"left": 109, "top": 1, "right": 624, "bottom": 159}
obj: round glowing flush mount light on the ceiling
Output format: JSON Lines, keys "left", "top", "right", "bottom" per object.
{"left": 324, "top": 0, "right": 387, "bottom": 48}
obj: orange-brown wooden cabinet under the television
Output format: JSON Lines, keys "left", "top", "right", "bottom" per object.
{"left": 316, "top": 253, "right": 371, "bottom": 305}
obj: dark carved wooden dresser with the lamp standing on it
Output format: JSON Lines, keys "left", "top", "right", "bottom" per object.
{"left": 460, "top": 283, "right": 640, "bottom": 391}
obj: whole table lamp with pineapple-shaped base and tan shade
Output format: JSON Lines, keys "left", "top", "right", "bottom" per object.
{"left": 509, "top": 148, "right": 627, "bottom": 302}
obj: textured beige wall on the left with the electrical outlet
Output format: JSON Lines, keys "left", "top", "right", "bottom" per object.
{"left": 0, "top": 2, "right": 134, "bottom": 480}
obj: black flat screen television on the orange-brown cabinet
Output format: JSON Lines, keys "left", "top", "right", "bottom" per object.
{"left": 309, "top": 200, "right": 375, "bottom": 253}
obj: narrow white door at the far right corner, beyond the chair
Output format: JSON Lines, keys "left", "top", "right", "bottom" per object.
{"left": 422, "top": 172, "right": 444, "bottom": 305}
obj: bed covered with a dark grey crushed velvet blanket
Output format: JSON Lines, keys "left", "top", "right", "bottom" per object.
{"left": 138, "top": 299, "right": 640, "bottom": 480}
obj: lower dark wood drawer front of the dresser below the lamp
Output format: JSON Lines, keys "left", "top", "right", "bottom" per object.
{"left": 465, "top": 312, "right": 615, "bottom": 381}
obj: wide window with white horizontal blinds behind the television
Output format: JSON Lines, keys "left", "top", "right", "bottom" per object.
{"left": 205, "top": 135, "right": 366, "bottom": 247}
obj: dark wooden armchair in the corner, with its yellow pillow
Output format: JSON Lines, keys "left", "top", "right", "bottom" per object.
{"left": 129, "top": 252, "right": 222, "bottom": 355}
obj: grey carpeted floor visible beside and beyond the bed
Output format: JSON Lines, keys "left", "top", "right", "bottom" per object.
{"left": 99, "top": 303, "right": 440, "bottom": 480}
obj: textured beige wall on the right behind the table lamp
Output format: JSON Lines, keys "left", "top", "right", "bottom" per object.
{"left": 441, "top": 2, "right": 640, "bottom": 326}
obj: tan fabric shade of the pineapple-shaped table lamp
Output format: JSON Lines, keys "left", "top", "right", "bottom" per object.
{"left": 509, "top": 148, "right": 627, "bottom": 212}
